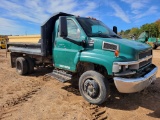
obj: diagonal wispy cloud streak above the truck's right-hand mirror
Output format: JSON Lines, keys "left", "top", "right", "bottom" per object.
{"left": 108, "top": 2, "right": 130, "bottom": 23}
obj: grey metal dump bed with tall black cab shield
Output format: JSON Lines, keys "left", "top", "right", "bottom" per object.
{"left": 7, "top": 12, "right": 72, "bottom": 57}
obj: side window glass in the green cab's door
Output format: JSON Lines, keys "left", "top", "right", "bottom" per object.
{"left": 67, "top": 19, "right": 80, "bottom": 39}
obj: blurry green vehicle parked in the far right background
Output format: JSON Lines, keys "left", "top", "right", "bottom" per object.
{"left": 137, "top": 31, "right": 160, "bottom": 49}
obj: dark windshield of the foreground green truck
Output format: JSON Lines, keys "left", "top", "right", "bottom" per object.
{"left": 77, "top": 18, "right": 121, "bottom": 38}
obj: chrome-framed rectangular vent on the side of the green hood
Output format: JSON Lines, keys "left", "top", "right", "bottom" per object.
{"left": 102, "top": 42, "right": 118, "bottom": 51}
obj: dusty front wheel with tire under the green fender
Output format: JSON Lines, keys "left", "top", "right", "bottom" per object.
{"left": 79, "top": 71, "right": 109, "bottom": 104}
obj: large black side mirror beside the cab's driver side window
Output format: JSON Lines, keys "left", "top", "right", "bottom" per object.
{"left": 59, "top": 16, "right": 68, "bottom": 37}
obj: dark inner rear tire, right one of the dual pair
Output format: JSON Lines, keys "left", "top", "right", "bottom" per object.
{"left": 26, "top": 57, "right": 34, "bottom": 74}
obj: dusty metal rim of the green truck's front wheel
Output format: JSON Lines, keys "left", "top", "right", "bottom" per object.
{"left": 83, "top": 79, "right": 99, "bottom": 98}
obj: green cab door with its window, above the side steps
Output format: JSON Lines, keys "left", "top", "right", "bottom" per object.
{"left": 53, "top": 19, "right": 83, "bottom": 71}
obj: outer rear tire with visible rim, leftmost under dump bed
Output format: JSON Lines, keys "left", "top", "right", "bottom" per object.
{"left": 16, "top": 57, "right": 28, "bottom": 75}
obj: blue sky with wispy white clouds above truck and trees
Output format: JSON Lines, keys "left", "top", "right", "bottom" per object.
{"left": 0, "top": 0, "right": 160, "bottom": 35}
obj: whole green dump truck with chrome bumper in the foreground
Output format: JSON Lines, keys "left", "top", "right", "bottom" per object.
{"left": 7, "top": 12, "right": 157, "bottom": 104}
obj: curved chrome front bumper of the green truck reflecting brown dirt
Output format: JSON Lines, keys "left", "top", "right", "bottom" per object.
{"left": 113, "top": 67, "right": 158, "bottom": 93}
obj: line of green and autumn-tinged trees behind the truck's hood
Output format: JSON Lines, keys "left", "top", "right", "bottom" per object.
{"left": 118, "top": 19, "right": 160, "bottom": 39}
